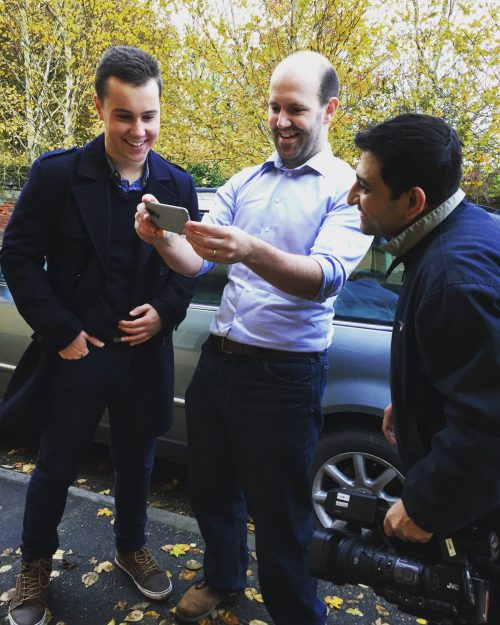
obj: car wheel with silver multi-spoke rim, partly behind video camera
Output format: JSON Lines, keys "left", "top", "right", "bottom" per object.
{"left": 312, "top": 430, "right": 404, "bottom": 528}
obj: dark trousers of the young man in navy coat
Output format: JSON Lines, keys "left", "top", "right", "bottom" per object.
{"left": 21, "top": 344, "right": 155, "bottom": 561}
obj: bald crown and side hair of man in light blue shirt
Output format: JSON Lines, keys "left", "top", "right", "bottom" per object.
{"left": 271, "top": 50, "right": 339, "bottom": 105}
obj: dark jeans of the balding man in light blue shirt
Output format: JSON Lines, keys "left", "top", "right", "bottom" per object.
{"left": 186, "top": 339, "right": 327, "bottom": 625}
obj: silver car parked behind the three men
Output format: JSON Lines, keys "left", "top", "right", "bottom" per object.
{"left": 0, "top": 189, "right": 403, "bottom": 527}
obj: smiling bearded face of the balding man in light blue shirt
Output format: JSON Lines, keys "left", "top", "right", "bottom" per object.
{"left": 268, "top": 67, "right": 338, "bottom": 169}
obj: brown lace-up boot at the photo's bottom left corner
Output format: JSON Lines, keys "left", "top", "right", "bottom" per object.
{"left": 9, "top": 558, "right": 52, "bottom": 625}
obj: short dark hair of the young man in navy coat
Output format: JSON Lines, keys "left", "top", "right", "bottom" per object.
{"left": 94, "top": 46, "right": 163, "bottom": 101}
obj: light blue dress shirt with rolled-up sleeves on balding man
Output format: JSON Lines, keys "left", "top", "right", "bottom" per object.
{"left": 198, "top": 146, "right": 372, "bottom": 352}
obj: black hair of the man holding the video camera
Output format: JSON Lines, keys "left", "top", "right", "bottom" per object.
{"left": 354, "top": 113, "right": 462, "bottom": 206}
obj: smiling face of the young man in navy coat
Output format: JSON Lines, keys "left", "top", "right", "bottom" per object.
{"left": 94, "top": 76, "right": 160, "bottom": 180}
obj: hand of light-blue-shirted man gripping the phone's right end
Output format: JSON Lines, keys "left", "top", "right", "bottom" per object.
{"left": 184, "top": 221, "right": 254, "bottom": 264}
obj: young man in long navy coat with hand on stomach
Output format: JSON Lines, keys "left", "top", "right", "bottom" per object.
{"left": 0, "top": 46, "right": 199, "bottom": 625}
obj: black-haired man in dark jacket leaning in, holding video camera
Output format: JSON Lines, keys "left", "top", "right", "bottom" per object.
{"left": 348, "top": 114, "right": 500, "bottom": 623}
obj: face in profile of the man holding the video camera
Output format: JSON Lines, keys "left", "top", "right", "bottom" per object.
{"left": 347, "top": 152, "right": 414, "bottom": 238}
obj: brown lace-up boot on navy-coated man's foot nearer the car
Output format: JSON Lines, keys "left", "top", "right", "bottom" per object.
{"left": 115, "top": 546, "right": 172, "bottom": 601}
